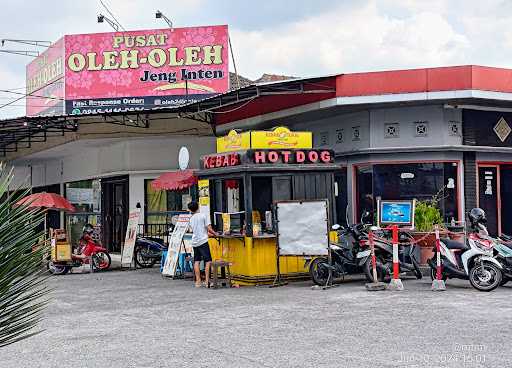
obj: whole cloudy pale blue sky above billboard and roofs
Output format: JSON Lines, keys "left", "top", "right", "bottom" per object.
{"left": 0, "top": 0, "right": 512, "bottom": 118}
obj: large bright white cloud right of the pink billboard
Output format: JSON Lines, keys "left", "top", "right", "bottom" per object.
{"left": 232, "top": 1, "right": 470, "bottom": 78}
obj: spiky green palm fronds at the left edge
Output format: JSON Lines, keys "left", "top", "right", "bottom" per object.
{"left": 0, "top": 164, "right": 50, "bottom": 347}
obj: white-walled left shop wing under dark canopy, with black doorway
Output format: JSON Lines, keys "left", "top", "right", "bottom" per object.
{"left": 7, "top": 113, "right": 215, "bottom": 252}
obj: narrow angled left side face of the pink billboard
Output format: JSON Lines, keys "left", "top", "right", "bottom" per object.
{"left": 26, "top": 38, "right": 64, "bottom": 116}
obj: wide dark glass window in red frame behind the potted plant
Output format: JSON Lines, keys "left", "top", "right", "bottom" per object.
{"left": 356, "top": 162, "right": 458, "bottom": 222}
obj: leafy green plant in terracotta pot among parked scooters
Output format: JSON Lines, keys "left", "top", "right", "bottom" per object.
{"left": 412, "top": 188, "right": 445, "bottom": 264}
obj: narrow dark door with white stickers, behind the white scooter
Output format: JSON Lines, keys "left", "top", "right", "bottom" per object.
{"left": 478, "top": 166, "right": 500, "bottom": 235}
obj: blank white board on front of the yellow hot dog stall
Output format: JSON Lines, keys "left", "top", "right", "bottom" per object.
{"left": 276, "top": 200, "right": 329, "bottom": 256}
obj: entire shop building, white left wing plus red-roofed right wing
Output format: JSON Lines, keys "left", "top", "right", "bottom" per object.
{"left": 7, "top": 66, "right": 512, "bottom": 251}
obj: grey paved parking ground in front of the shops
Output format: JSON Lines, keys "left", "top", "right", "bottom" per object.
{"left": 0, "top": 269, "right": 512, "bottom": 368}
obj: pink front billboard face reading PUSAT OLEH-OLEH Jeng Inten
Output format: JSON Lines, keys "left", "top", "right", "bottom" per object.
{"left": 64, "top": 25, "right": 229, "bottom": 115}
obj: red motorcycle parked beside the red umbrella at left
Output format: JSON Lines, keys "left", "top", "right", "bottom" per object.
{"left": 47, "top": 224, "right": 112, "bottom": 275}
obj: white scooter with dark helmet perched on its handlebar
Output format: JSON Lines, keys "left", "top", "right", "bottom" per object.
{"left": 428, "top": 208, "right": 503, "bottom": 291}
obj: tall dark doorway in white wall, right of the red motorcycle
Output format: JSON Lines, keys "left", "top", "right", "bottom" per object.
{"left": 101, "top": 176, "right": 129, "bottom": 253}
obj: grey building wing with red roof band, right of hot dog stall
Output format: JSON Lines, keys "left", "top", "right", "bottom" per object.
{"left": 184, "top": 66, "right": 512, "bottom": 237}
